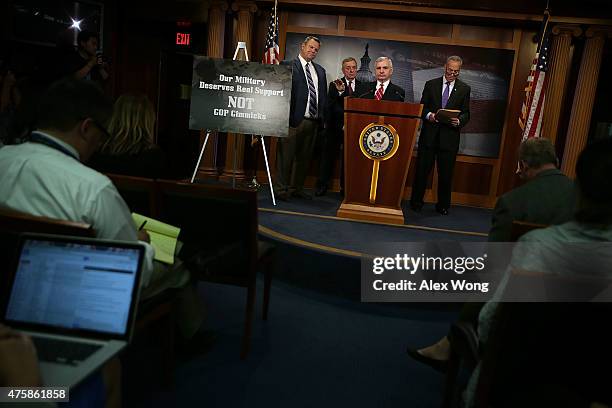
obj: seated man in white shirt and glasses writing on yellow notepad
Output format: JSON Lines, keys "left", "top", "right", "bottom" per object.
{"left": 0, "top": 78, "right": 202, "bottom": 340}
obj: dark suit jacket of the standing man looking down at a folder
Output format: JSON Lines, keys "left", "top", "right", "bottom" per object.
{"left": 419, "top": 77, "right": 470, "bottom": 152}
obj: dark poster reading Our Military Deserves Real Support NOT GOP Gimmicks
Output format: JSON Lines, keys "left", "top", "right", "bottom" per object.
{"left": 189, "top": 56, "right": 291, "bottom": 137}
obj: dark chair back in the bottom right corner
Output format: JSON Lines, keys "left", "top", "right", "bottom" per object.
{"left": 475, "top": 302, "right": 612, "bottom": 408}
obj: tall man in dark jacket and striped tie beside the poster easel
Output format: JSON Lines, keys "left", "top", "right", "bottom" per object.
{"left": 276, "top": 36, "right": 327, "bottom": 201}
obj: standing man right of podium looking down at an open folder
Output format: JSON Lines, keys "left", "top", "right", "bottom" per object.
{"left": 410, "top": 56, "right": 470, "bottom": 215}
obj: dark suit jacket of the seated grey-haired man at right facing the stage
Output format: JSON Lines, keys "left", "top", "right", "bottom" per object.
{"left": 489, "top": 169, "right": 578, "bottom": 242}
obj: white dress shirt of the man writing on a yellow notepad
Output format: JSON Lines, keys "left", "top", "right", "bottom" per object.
{"left": 0, "top": 132, "right": 155, "bottom": 286}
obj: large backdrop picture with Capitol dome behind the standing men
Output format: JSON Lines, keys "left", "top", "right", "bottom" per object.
{"left": 285, "top": 33, "right": 518, "bottom": 157}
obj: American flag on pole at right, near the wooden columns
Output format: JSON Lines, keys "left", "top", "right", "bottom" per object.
{"left": 519, "top": 9, "right": 550, "bottom": 140}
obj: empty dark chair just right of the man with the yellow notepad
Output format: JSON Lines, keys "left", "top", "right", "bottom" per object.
{"left": 157, "top": 180, "right": 275, "bottom": 359}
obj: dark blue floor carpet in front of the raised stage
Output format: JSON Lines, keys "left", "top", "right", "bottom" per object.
{"left": 144, "top": 282, "right": 454, "bottom": 408}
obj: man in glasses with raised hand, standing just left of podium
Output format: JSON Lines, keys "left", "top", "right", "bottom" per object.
{"left": 315, "top": 57, "right": 361, "bottom": 196}
